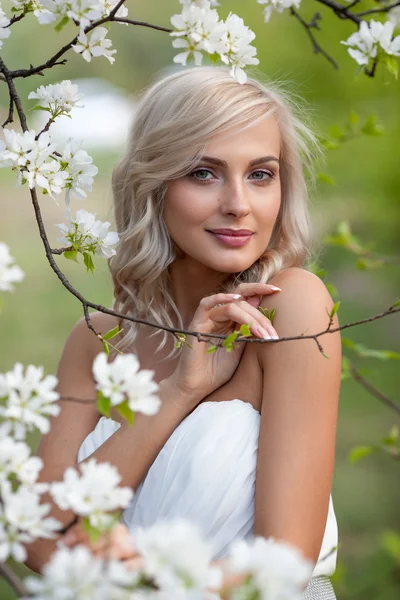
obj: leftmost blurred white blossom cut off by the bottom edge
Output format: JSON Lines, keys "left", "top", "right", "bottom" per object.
{"left": 24, "top": 546, "right": 138, "bottom": 600}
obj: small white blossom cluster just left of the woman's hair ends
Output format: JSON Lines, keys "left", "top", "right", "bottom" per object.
{"left": 56, "top": 210, "right": 119, "bottom": 258}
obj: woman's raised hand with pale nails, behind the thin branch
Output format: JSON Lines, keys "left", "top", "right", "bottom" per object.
{"left": 168, "top": 283, "right": 280, "bottom": 410}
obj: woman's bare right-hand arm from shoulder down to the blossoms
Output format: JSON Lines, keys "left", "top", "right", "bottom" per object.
{"left": 255, "top": 268, "right": 341, "bottom": 563}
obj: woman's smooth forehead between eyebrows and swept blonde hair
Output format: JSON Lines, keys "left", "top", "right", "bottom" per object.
{"left": 204, "top": 115, "right": 281, "bottom": 160}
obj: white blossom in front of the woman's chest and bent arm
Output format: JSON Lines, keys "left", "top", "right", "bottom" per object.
{"left": 93, "top": 352, "right": 161, "bottom": 415}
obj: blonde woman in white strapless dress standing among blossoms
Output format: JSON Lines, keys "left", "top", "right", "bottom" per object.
{"left": 28, "top": 67, "right": 341, "bottom": 599}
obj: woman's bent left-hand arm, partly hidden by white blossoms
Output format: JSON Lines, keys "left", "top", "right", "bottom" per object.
{"left": 26, "top": 314, "right": 194, "bottom": 572}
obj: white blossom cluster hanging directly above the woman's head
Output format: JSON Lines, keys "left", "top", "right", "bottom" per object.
{"left": 170, "top": 0, "right": 259, "bottom": 83}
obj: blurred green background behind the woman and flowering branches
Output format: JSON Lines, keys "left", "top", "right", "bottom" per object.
{"left": 0, "top": 0, "right": 400, "bottom": 600}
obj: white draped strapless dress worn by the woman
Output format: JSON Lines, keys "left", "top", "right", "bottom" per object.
{"left": 78, "top": 399, "right": 338, "bottom": 577}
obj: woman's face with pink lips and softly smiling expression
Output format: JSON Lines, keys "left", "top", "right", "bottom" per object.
{"left": 164, "top": 115, "right": 281, "bottom": 273}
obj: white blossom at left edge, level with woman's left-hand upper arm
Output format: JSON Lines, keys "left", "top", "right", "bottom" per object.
{"left": 0, "top": 363, "right": 60, "bottom": 440}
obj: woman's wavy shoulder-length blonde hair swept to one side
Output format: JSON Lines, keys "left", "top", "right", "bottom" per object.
{"left": 109, "top": 66, "right": 322, "bottom": 356}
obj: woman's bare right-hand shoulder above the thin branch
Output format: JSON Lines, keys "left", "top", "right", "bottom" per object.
{"left": 260, "top": 267, "right": 340, "bottom": 345}
